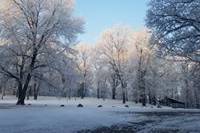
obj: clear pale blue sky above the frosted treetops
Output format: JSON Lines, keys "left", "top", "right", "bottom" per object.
{"left": 75, "top": 0, "right": 148, "bottom": 43}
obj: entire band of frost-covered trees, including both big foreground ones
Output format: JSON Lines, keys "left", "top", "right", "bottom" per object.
{"left": 0, "top": 0, "right": 200, "bottom": 108}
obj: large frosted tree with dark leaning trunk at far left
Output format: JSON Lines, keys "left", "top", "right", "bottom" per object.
{"left": 0, "top": 0, "right": 83, "bottom": 105}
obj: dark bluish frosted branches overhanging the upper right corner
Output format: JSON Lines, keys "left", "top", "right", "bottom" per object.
{"left": 147, "top": 0, "right": 200, "bottom": 62}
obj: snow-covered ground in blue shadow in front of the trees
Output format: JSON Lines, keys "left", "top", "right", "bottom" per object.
{"left": 0, "top": 97, "right": 200, "bottom": 133}
